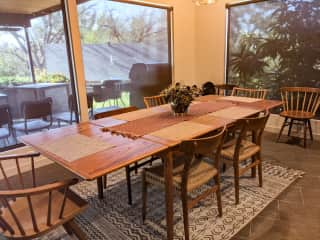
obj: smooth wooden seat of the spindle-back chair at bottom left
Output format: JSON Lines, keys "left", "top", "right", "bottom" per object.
{"left": 0, "top": 191, "right": 86, "bottom": 238}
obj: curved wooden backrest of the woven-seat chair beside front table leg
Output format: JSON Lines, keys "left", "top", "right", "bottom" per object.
{"left": 179, "top": 127, "right": 226, "bottom": 186}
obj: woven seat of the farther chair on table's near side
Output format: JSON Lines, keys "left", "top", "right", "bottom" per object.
{"left": 221, "top": 140, "right": 260, "bottom": 162}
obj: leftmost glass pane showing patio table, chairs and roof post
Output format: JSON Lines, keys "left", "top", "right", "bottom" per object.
{"left": 0, "top": 3, "right": 77, "bottom": 148}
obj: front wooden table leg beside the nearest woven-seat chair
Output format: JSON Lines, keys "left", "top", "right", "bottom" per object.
{"left": 164, "top": 152, "right": 173, "bottom": 240}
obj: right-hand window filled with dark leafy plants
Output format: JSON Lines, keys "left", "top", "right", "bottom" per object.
{"left": 227, "top": 0, "right": 320, "bottom": 99}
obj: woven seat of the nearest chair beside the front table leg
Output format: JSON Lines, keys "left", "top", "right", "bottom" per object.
{"left": 145, "top": 157, "right": 218, "bottom": 192}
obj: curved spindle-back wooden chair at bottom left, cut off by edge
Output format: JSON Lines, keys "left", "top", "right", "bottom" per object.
{"left": 0, "top": 153, "right": 87, "bottom": 239}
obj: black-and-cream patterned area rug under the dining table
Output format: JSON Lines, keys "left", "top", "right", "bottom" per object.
{"left": 42, "top": 163, "right": 303, "bottom": 240}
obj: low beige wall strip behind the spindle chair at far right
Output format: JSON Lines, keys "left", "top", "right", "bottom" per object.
{"left": 266, "top": 114, "right": 320, "bottom": 140}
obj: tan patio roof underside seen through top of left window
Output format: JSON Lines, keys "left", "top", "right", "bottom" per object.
{"left": 0, "top": 0, "right": 60, "bottom": 14}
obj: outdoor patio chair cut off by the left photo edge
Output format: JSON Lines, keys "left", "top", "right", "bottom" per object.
{"left": 0, "top": 104, "right": 15, "bottom": 145}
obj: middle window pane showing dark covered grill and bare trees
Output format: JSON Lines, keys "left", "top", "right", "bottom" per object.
{"left": 78, "top": 0, "right": 171, "bottom": 115}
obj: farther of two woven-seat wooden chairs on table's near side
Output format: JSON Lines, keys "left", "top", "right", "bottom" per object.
{"left": 221, "top": 113, "right": 270, "bottom": 204}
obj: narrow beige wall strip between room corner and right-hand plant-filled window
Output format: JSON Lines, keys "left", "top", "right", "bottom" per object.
{"left": 195, "top": 0, "right": 235, "bottom": 84}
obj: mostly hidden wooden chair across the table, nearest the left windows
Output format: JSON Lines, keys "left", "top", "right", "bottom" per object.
{"left": 94, "top": 106, "right": 155, "bottom": 205}
